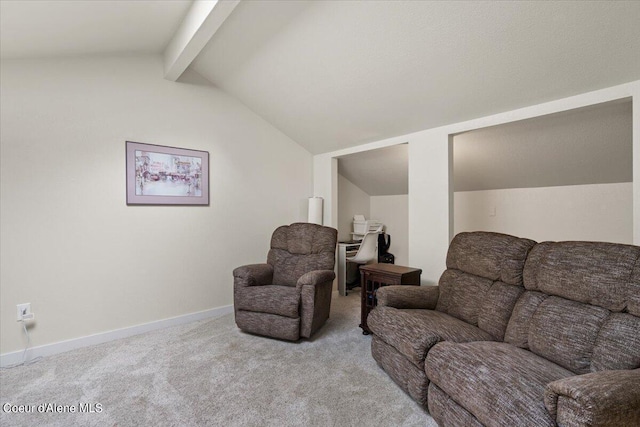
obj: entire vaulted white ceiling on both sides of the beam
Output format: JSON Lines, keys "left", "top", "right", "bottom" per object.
{"left": 0, "top": 0, "right": 640, "bottom": 159}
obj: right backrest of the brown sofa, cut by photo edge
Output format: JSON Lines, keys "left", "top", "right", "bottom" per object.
{"left": 504, "top": 242, "right": 640, "bottom": 374}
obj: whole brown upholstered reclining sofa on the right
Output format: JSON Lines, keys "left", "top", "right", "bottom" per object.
{"left": 368, "top": 232, "right": 640, "bottom": 427}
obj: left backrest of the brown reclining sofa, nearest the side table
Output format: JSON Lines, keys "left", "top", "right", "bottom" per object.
{"left": 436, "top": 231, "right": 536, "bottom": 341}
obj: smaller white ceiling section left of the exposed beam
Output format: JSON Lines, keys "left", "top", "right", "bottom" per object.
{"left": 0, "top": 0, "right": 192, "bottom": 59}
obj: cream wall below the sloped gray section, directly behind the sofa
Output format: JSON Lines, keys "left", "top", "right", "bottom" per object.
{"left": 454, "top": 183, "right": 633, "bottom": 244}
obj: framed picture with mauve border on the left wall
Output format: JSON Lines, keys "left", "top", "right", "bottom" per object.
{"left": 126, "top": 141, "right": 209, "bottom": 206}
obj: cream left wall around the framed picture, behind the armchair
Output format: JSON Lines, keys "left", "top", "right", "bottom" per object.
{"left": 0, "top": 56, "right": 312, "bottom": 353}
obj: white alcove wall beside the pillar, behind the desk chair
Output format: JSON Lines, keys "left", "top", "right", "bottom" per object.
{"left": 371, "top": 194, "right": 409, "bottom": 265}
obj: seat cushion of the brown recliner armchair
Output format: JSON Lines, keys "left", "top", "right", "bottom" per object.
{"left": 235, "top": 285, "right": 300, "bottom": 318}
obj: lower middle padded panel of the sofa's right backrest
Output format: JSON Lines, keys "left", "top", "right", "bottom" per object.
{"left": 529, "top": 297, "right": 610, "bottom": 374}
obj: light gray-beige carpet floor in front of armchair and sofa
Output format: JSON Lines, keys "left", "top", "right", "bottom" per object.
{"left": 0, "top": 292, "right": 436, "bottom": 427}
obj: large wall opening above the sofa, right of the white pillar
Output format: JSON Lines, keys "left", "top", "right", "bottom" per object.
{"left": 450, "top": 98, "right": 633, "bottom": 244}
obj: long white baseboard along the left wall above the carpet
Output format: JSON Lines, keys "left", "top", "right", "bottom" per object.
{"left": 0, "top": 305, "right": 233, "bottom": 368}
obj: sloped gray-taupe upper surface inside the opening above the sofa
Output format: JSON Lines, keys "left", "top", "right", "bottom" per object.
{"left": 453, "top": 99, "right": 632, "bottom": 191}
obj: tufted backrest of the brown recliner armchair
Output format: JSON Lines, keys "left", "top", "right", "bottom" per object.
{"left": 267, "top": 222, "right": 338, "bottom": 286}
